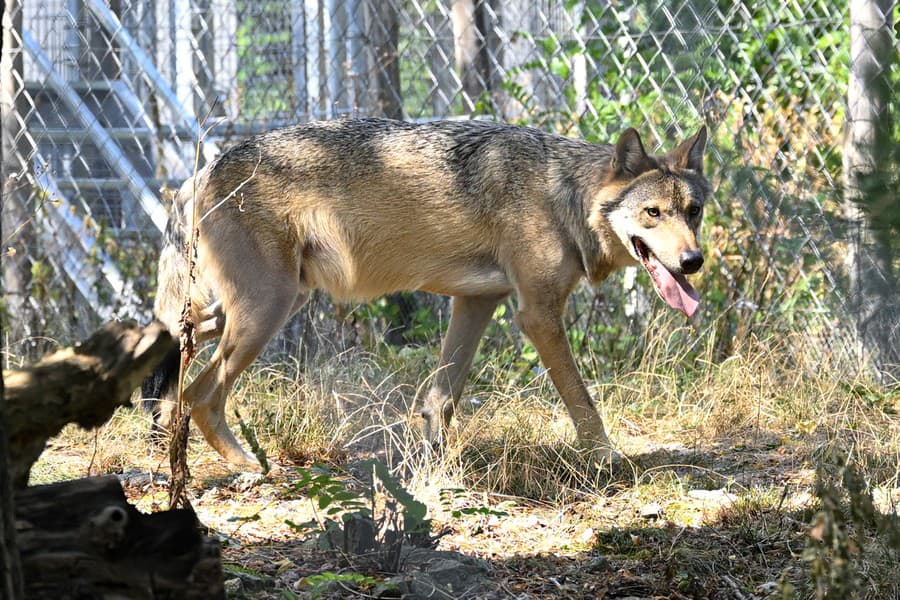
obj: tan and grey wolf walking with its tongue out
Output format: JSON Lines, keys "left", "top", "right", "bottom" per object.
{"left": 139, "top": 119, "right": 710, "bottom": 468}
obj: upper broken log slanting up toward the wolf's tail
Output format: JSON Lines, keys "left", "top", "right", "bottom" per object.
{"left": 3, "top": 322, "right": 175, "bottom": 488}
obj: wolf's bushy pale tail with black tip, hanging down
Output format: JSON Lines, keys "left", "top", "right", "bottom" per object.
{"left": 141, "top": 175, "right": 199, "bottom": 431}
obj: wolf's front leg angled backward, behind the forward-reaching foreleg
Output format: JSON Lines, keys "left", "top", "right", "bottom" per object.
{"left": 422, "top": 294, "right": 506, "bottom": 443}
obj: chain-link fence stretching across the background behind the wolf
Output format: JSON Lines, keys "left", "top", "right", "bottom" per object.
{"left": 2, "top": 0, "right": 900, "bottom": 378}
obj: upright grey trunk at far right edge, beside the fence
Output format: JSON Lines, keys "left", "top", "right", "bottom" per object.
{"left": 843, "top": 0, "right": 900, "bottom": 379}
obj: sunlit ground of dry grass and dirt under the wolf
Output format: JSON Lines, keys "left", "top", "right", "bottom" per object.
{"left": 24, "top": 344, "right": 900, "bottom": 599}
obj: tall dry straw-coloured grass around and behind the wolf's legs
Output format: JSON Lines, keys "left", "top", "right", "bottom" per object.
{"left": 33, "top": 308, "right": 900, "bottom": 501}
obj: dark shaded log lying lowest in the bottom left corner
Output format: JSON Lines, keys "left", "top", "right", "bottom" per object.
{"left": 15, "top": 475, "right": 225, "bottom": 600}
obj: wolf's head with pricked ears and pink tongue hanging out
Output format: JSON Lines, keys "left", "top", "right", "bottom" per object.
{"left": 600, "top": 127, "right": 710, "bottom": 317}
